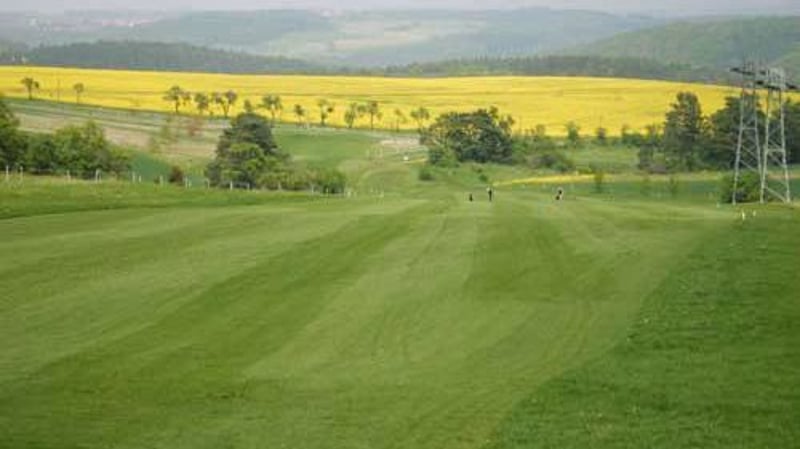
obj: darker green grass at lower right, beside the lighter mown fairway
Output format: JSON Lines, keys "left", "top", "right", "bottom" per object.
{"left": 487, "top": 208, "right": 800, "bottom": 448}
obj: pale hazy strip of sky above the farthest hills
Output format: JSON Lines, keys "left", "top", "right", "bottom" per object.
{"left": 0, "top": 0, "right": 800, "bottom": 15}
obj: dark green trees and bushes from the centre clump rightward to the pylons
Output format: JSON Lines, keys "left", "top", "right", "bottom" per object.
{"left": 420, "top": 92, "right": 800, "bottom": 178}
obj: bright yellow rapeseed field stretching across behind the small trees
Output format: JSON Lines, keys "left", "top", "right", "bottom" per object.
{"left": 0, "top": 67, "right": 736, "bottom": 134}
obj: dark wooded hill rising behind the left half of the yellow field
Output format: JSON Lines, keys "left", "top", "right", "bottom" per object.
{"left": 5, "top": 41, "right": 322, "bottom": 74}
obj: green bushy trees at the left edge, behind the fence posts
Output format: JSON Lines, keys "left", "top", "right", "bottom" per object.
{"left": 0, "top": 95, "right": 130, "bottom": 177}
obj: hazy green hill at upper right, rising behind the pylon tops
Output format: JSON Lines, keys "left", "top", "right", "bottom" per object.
{"left": 564, "top": 17, "right": 800, "bottom": 76}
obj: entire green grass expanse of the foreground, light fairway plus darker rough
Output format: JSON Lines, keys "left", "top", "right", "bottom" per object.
{"left": 0, "top": 170, "right": 800, "bottom": 448}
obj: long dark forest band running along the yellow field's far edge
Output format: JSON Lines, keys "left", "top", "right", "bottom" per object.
{"left": 0, "top": 41, "right": 733, "bottom": 83}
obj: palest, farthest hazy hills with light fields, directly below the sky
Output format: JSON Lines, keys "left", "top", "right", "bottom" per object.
{"left": 0, "top": 8, "right": 662, "bottom": 68}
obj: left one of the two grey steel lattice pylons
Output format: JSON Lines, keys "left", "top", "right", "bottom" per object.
{"left": 732, "top": 62, "right": 762, "bottom": 204}
